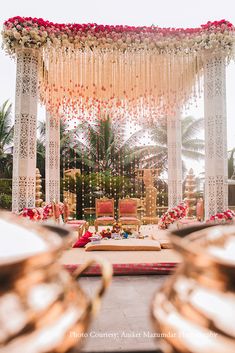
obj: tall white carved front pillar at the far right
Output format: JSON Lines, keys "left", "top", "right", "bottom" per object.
{"left": 204, "top": 55, "right": 228, "bottom": 218}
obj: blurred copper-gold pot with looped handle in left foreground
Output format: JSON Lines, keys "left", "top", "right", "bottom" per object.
{"left": 0, "top": 213, "right": 112, "bottom": 353}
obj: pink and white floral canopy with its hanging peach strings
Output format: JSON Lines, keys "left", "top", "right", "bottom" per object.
{"left": 2, "top": 17, "right": 234, "bottom": 121}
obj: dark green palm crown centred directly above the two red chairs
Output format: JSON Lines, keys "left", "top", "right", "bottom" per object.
{"left": 73, "top": 117, "right": 140, "bottom": 175}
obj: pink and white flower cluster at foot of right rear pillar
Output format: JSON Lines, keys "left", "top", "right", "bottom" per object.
{"left": 158, "top": 202, "right": 188, "bottom": 229}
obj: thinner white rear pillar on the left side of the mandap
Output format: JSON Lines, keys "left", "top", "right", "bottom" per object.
{"left": 46, "top": 112, "right": 60, "bottom": 202}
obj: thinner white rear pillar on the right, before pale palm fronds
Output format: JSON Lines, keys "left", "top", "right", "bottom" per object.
{"left": 167, "top": 111, "right": 182, "bottom": 208}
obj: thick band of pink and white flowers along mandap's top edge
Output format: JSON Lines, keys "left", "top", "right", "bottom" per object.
{"left": 2, "top": 16, "right": 234, "bottom": 54}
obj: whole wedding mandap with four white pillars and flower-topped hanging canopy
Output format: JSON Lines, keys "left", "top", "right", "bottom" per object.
{"left": 2, "top": 16, "right": 234, "bottom": 224}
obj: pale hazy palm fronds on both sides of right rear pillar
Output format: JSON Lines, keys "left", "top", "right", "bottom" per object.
{"left": 129, "top": 116, "right": 204, "bottom": 171}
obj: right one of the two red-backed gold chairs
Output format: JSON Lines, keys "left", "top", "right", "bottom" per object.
{"left": 118, "top": 198, "right": 141, "bottom": 230}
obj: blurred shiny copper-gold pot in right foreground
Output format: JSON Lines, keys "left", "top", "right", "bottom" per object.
{"left": 152, "top": 225, "right": 235, "bottom": 353}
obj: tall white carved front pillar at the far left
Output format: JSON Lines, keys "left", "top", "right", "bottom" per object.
{"left": 12, "top": 49, "right": 38, "bottom": 213}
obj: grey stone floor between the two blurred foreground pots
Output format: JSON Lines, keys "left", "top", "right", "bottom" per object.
{"left": 80, "top": 275, "right": 168, "bottom": 352}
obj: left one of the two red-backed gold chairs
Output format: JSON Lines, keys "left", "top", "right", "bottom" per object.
{"left": 94, "top": 198, "right": 115, "bottom": 232}
